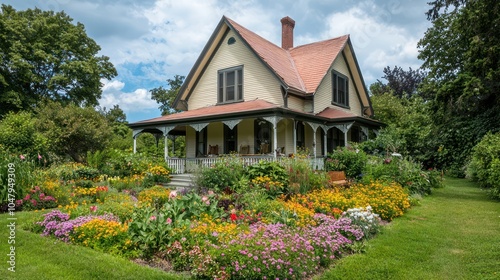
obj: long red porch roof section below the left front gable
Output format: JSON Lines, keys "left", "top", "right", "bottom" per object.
{"left": 135, "top": 99, "right": 279, "bottom": 124}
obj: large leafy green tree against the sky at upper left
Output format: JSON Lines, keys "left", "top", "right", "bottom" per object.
{"left": 0, "top": 5, "right": 117, "bottom": 117}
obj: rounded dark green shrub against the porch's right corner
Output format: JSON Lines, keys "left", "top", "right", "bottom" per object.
{"left": 325, "top": 147, "right": 367, "bottom": 179}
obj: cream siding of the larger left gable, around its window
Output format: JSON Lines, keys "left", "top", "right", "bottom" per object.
{"left": 188, "top": 31, "right": 283, "bottom": 110}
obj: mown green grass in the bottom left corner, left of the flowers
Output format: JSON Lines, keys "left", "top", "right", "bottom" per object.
{"left": 0, "top": 212, "right": 186, "bottom": 280}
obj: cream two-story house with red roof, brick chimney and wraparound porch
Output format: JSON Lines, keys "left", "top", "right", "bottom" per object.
{"left": 130, "top": 16, "right": 382, "bottom": 172}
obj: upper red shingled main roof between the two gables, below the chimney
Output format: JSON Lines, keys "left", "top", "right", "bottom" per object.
{"left": 225, "top": 17, "right": 349, "bottom": 94}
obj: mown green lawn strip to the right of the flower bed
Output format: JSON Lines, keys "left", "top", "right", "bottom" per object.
{"left": 317, "top": 178, "right": 500, "bottom": 280}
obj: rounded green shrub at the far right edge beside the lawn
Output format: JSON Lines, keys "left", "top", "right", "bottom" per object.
{"left": 467, "top": 133, "right": 500, "bottom": 199}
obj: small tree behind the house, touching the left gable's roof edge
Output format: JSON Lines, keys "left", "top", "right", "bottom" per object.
{"left": 151, "top": 75, "right": 185, "bottom": 116}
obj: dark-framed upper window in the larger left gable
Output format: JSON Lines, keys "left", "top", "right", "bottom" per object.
{"left": 217, "top": 66, "right": 243, "bottom": 103}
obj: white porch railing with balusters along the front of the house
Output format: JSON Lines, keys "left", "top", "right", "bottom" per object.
{"left": 166, "top": 156, "right": 324, "bottom": 174}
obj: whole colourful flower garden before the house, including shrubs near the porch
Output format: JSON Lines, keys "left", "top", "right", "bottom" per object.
{"left": 3, "top": 148, "right": 441, "bottom": 279}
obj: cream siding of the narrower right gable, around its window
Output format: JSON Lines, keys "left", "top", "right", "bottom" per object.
{"left": 314, "top": 53, "right": 362, "bottom": 116}
